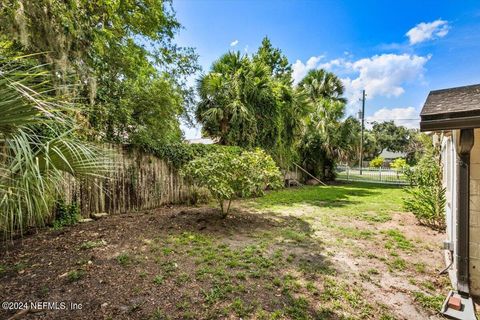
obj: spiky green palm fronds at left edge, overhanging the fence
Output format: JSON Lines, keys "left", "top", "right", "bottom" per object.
{"left": 0, "top": 59, "right": 110, "bottom": 236}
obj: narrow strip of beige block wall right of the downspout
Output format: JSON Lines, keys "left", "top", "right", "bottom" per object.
{"left": 470, "top": 129, "right": 480, "bottom": 297}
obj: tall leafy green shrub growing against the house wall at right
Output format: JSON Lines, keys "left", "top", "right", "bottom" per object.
{"left": 404, "top": 137, "right": 446, "bottom": 230}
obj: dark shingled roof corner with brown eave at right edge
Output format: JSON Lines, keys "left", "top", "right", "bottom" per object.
{"left": 420, "top": 84, "right": 480, "bottom": 131}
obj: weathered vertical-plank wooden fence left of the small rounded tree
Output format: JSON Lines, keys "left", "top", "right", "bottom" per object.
{"left": 64, "top": 145, "right": 199, "bottom": 216}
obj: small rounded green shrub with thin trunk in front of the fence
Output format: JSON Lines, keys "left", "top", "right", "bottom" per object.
{"left": 181, "top": 149, "right": 282, "bottom": 216}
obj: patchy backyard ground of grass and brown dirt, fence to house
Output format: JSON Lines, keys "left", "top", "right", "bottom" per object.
{"left": 0, "top": 183, "right": 449, "bottom": 320}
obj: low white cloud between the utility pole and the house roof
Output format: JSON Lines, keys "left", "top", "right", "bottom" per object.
{"left": 365, "top": 107, "right": 420, "bottom": 129}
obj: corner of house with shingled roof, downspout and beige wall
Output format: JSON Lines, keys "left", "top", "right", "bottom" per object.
{"left": 420, "top": 85, "right": 480, "bottom": 319}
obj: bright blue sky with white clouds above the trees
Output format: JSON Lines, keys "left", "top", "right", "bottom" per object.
{"left": 173, "top": 0, "right": 480, "bottom": 138}
